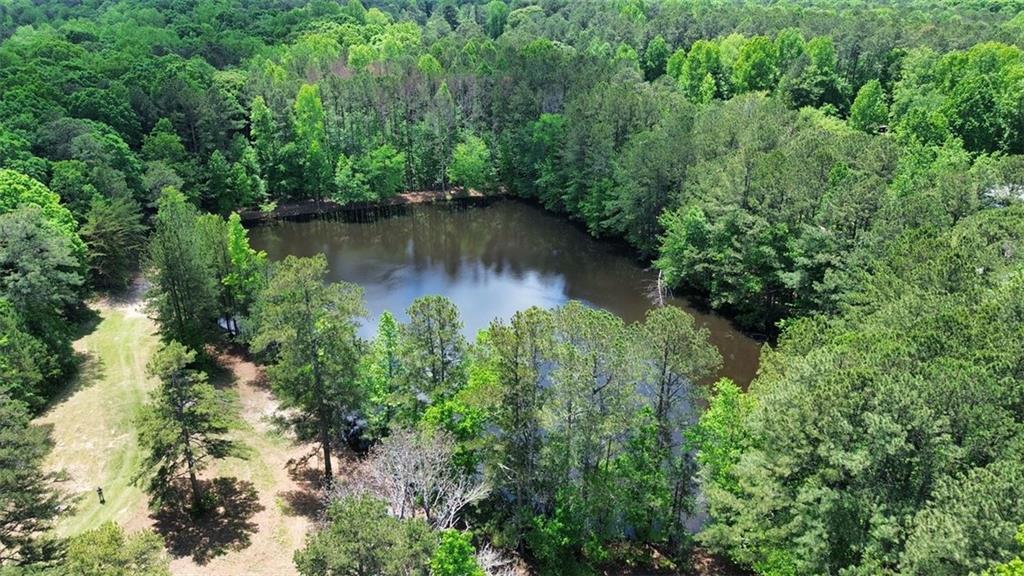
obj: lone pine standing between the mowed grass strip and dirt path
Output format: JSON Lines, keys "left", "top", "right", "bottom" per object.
{"left": 137, "top": 341, "right": 242, "bottom": 506}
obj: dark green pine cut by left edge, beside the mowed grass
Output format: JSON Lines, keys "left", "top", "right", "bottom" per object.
{"left": 0, "top": 395, "right": 63, "bottom": 570}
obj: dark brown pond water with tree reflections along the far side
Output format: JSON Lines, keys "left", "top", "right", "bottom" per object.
{"left": 252, "top": 200, "right": 759, "bottom": 382}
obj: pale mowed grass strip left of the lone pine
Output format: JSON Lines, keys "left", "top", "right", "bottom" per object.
{"left": 37, "top": 305, "right": 160, "bottom": 536}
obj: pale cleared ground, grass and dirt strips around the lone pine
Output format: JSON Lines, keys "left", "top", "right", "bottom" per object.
{"left": 36, "top": 291, "right": 321, "bottom": 576}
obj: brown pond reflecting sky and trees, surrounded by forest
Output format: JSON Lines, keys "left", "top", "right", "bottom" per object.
{"left": 250, "top": 200, "right": 761, "bottom": 386}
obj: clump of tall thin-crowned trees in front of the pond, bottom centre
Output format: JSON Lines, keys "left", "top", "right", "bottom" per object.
{"left": 474, "top": 302, "right": 720, "bottom": 561}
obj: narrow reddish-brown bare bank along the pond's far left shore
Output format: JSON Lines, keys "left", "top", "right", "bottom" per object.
{"left": 239, "top": 189, "right": 495, "bottom": 223}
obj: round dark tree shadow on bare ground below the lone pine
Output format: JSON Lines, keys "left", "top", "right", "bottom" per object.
{"left": 152, "top": 478, "right": 263, "bottom": 566}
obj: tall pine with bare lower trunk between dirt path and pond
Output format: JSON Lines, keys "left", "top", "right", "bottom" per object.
{"left": 252, "top": 254, "right": 366, "bottom": 483}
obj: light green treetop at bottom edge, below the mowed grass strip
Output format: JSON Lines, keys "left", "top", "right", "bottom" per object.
{"left": 56, "top": 522, "right": 171, "bottom": 576}
